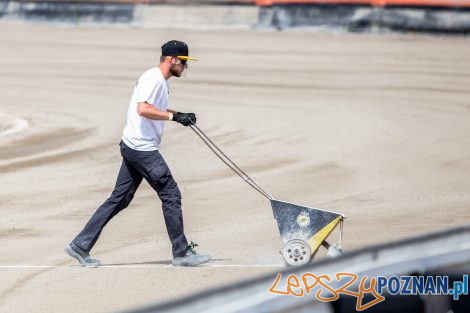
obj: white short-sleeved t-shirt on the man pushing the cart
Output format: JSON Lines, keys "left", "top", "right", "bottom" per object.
{"left": 122, "top": 67, "right": 169, "bottom": 151}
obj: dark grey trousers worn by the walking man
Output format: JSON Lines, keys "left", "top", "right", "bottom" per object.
{"left": 73, "top": 142, "right": 188, "bottom": 257}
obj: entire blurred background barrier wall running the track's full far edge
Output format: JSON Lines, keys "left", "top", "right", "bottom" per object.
{"left": 0, "top": 0, "right": 470, "bottom": 33}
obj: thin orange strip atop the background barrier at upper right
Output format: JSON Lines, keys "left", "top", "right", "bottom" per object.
{"left": 255, "top": 0, "right": 470, "bottom": 8}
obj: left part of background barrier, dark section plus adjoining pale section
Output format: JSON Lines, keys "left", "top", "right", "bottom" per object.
{"left": 0, "top": 0, "right": 259, "bottom": 29}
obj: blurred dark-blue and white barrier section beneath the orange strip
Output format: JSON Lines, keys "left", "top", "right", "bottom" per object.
{"left": 258, "top": 4, "right": 470, "bottom": 33}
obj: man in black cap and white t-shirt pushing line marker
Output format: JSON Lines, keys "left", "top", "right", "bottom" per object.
{"left": 65, "top": 40, "right": 210, "bottom": 267}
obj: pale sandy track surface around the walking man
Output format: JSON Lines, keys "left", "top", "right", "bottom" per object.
{"left": 0, "top": 25, "right": 470, "bottom": 313}
